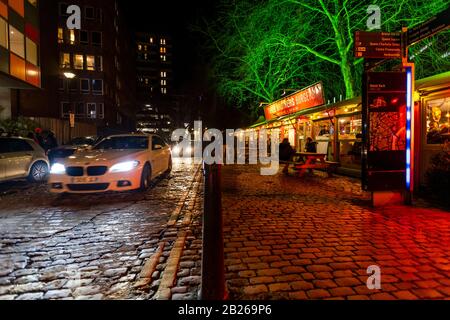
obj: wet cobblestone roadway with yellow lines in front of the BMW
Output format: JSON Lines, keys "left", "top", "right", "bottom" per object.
{"left": 0, "top": 163, "right": 203, "bottom": 300}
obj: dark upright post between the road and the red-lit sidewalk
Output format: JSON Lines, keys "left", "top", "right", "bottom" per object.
{"left": 200, "top": 164, "right": 226, "bottom": 300}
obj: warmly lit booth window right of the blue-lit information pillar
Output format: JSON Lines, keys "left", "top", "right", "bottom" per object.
{"left": 426, "top": 98, "right": 450, "bottom": 144}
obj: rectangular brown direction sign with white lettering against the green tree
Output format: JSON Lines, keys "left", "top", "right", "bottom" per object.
{"left": 355, "top": 31, "right": 402, "bottom": 59}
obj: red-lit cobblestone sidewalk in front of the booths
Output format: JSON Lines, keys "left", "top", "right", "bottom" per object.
{"left": 222, "top": 166, "right": 450, "bottom": 300}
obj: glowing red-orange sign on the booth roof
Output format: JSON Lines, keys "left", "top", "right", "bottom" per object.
{"left": 264, "top": 82, "right": 325, "bottom": 120}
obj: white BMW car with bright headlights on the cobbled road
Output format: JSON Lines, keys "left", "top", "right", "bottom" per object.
{"left": 49, "top": 134, "right": 172, "bottom": 193}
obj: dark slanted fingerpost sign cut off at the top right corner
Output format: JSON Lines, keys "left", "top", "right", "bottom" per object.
{"left": 407, "top": 7, "right": 450, "bottom": 46}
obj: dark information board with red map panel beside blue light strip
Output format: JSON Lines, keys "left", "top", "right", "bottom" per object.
{"left": 363, "top": 72, "right": 407, "bottom": 192}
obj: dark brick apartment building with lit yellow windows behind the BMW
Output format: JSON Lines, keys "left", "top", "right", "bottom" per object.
{"left": 12, "top": 0, "right": 136, "bottom": 141}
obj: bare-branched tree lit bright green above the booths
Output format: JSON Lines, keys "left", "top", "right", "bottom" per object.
{"left": 203, "top": 0, "right": 449, "bottom": 115}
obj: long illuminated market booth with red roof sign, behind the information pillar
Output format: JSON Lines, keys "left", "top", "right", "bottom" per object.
{"left": 249, "top": 72, "right": 450, "bottom": 191}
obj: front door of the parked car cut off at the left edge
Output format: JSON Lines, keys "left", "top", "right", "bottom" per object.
{"left": 5, "top": 138, "right": 34, "bottom": 178}
